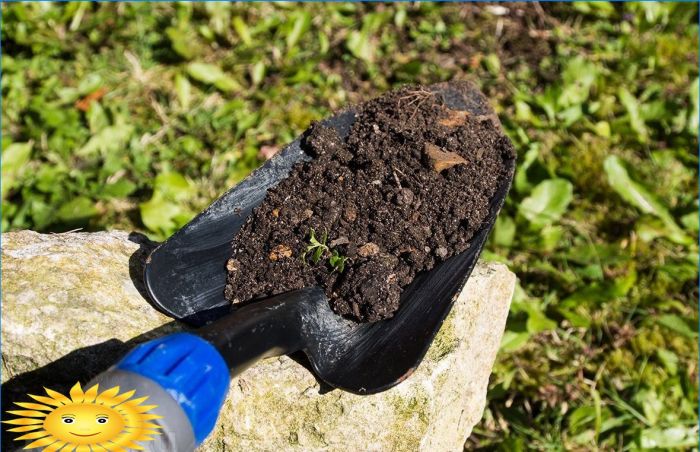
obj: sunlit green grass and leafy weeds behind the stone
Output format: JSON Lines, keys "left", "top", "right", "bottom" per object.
{"left": 2, "top": 2, "right": 698, "bottom": 450}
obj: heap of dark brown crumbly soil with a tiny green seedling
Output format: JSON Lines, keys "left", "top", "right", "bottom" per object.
{"left": 225, "top": 83, "right": 515, "bottom": 322}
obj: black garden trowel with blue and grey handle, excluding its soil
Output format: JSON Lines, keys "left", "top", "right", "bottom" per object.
{"left": 86, "top": 83, "right": 515, "bottom": 450}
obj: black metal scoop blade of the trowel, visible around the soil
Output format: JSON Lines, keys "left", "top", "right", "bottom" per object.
{"left": 145, "top": 83, "right": 515, "bottom": 394}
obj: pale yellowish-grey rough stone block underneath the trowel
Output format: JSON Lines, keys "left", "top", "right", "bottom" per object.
{"left": 2, "top": 231, "right": 515, "bottom": 452}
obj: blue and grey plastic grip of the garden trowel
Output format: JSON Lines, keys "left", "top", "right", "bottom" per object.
{"left": 88, "top": 333, "right": 229, "bottom": 452}
